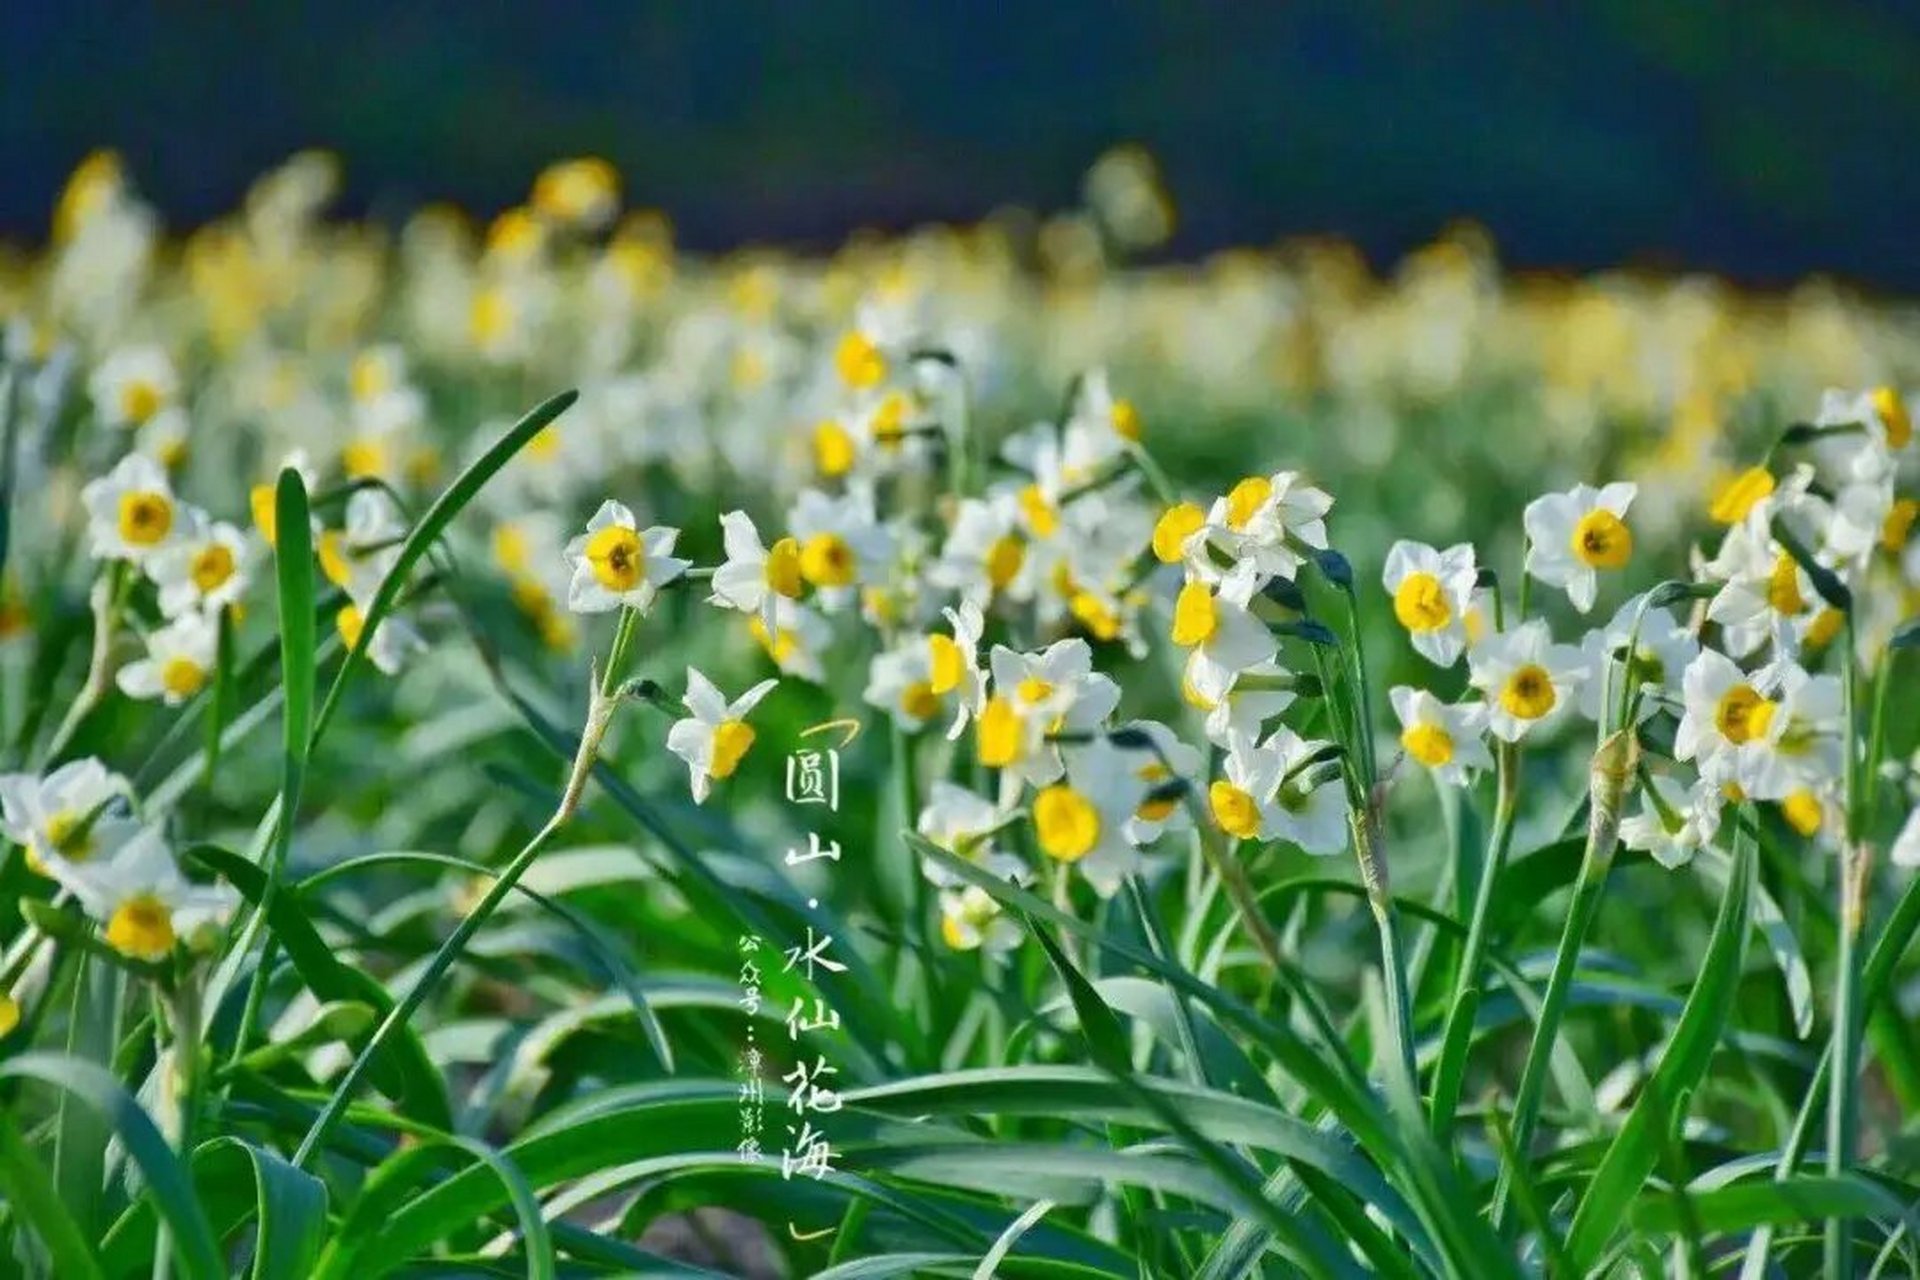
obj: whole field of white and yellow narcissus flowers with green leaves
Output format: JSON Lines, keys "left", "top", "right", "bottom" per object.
{"left": 0, "top": 150, "right": 1920, "bottom": 1280}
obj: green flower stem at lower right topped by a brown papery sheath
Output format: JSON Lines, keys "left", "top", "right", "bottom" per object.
{"left": 1492, "top": 729, "right": 1640, "bottom": 1230}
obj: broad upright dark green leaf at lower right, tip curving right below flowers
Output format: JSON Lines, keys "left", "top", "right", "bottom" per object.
{"left": 1567, "top": 835, "right": 1755, "bottom": 1274}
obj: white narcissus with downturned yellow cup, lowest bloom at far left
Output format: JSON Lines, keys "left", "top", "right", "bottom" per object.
{"left": 50, "top": 827, "right": 238, "bottom": 963}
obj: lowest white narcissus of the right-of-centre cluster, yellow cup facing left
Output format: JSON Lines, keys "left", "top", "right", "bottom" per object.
{"left": 1206, "top": 725, "right": 1346, "bottom": 854}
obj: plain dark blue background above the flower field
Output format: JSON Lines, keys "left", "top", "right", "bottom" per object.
{"left": 0, "top": 0, "right": 1920, "bottom": 290}
